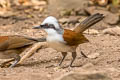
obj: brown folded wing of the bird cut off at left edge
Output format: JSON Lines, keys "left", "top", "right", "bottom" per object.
{"left": 0, "top": 35, "right": 36, "bottom": 50}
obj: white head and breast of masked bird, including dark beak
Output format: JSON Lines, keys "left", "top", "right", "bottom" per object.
{"left": 34, "top": 16, "right": 64, "bottom": 42}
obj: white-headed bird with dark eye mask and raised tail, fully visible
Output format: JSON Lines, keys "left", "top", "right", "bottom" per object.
{"left": 33, "top": 13, "right": 104, "bottom": 67}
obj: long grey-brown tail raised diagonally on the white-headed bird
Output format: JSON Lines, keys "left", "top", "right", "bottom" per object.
{"left": 73, "top": 13, "right": 104, "bottom": 33}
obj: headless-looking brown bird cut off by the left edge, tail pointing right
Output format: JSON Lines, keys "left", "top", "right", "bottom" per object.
{"left": 0, "top": 35, "right": 46, "bottom": 68}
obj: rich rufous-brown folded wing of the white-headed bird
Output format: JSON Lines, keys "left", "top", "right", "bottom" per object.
{"left": 63, "top": 29, "right": 88, "bottom": 46}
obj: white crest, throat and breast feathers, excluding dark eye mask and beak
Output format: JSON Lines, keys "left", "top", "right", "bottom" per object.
{"left": 42, "top": 16, "right": 64, "bottom": 42}
